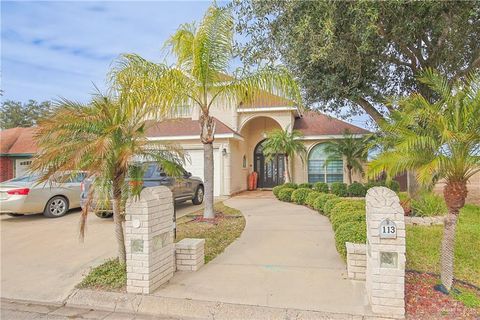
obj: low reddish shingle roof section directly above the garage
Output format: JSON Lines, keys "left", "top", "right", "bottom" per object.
{"left": 147, "top": 118, "right": 239, "bottom": 137}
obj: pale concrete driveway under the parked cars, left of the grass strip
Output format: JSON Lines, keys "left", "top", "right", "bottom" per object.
{"left": 0, "top": 198, "right": 222, "bottom": 302}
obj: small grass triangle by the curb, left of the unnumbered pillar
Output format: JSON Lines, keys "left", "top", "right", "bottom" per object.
{"left": 78, "top": 259, "right": 127, "bottom": 291}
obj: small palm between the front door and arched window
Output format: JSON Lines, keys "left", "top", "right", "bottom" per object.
{"left": 262, "top": 128, "right": 307, "bottom": 182}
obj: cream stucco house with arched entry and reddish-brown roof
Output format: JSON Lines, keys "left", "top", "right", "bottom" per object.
{"left": 147, "top": 94, "right": 369, "bottom": 195}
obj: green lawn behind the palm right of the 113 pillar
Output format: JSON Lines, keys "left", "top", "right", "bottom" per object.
{"left": 407, "top": 205, "right": 480, "bottom": 286}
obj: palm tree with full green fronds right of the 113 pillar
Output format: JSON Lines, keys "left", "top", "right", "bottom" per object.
{"left": 368, "top": 70, "right": 480, "bottom": 292}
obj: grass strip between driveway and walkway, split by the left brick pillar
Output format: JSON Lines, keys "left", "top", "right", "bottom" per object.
{"left": 77, "top": 202, "right": 245, "bottom": 291}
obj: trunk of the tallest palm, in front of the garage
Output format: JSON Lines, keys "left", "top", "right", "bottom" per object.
{"left": 200, "top": 114, "right": 215, "bottom": 219}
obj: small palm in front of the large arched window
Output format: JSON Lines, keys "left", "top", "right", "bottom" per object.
{"left": 325, "top": 130, "right": 368, "bottom": 184}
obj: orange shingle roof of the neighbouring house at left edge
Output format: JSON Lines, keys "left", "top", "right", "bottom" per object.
{"left": 0, "top": 127, "right": 38, "bottom": 154}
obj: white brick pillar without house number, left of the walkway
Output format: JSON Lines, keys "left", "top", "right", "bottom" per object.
{"left": 125, "top": 187, "right": 175, "bottom": 294}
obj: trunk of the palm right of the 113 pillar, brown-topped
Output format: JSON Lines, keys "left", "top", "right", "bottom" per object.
{"left": 440, "top": 181, "right": 468, "bottom": 291}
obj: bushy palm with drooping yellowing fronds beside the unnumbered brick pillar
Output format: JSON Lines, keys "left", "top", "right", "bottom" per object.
{"left": 31, "top": 94, "right": 183, "bottom": 263}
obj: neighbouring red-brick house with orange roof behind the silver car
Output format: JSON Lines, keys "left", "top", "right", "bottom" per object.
{"left": 0, "top": 128, "right": 37, "bottom": 182}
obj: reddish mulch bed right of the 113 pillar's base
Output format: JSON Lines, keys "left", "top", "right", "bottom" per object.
{"left": 405, "top": 272, "right": 480, "bottom": 320}
